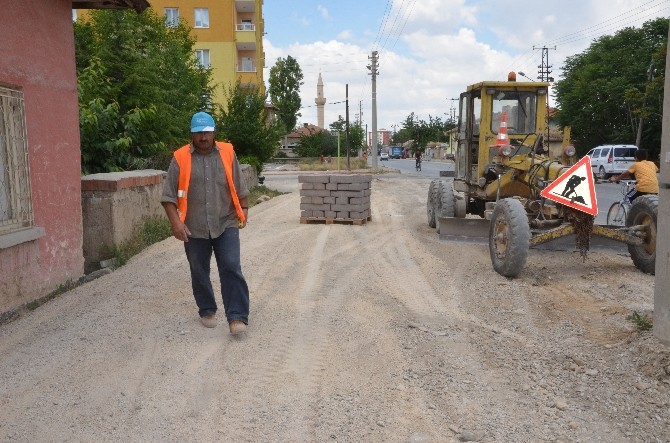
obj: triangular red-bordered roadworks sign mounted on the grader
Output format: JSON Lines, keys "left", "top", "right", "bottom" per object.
{"left": 540, "top": 155, "right": 598, "bottom": 216}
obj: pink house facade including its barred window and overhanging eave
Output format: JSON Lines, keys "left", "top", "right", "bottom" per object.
{"left": 0, "top": 0, "right": 148, "bottom": 320}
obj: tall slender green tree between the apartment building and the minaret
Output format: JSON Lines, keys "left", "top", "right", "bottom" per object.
{"left": 268, "top": 55, "right": 303, "bottom": 132}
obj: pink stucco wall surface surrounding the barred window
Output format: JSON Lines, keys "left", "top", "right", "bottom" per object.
{"left": 0, "top": 0, "right": 84, "bottom": 314}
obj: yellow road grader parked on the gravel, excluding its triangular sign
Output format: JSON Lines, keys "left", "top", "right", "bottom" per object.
{"left": 426, "top": 73, "right": 658, "bottom": 277}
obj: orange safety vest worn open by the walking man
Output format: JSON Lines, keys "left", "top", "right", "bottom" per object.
{"left": 174, "top": 142, "right": 246, "bottom": 223}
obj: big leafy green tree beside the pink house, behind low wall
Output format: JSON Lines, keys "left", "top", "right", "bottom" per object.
{"left": 74, "top": 10, "right": 212, "bottom": 173}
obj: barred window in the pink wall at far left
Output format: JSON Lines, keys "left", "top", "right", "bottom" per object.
{"left": 0, "top": 86, "right": 34, "bottom": 235}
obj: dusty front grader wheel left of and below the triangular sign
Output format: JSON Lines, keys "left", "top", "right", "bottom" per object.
{"left": 489, "top": 198, "right": 530, "bottom": 277}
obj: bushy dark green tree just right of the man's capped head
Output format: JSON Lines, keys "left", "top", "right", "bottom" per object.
{"left": 215, "top": 80, "right": 283, "bottom": 173}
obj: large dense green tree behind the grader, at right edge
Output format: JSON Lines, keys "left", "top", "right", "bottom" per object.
{"left": 555, "top": 18, "right": 668, "bottom": 158}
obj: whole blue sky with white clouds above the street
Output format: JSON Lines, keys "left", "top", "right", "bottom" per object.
{"left": 263, "top": 0, "right": 670, "bottom": 131}
